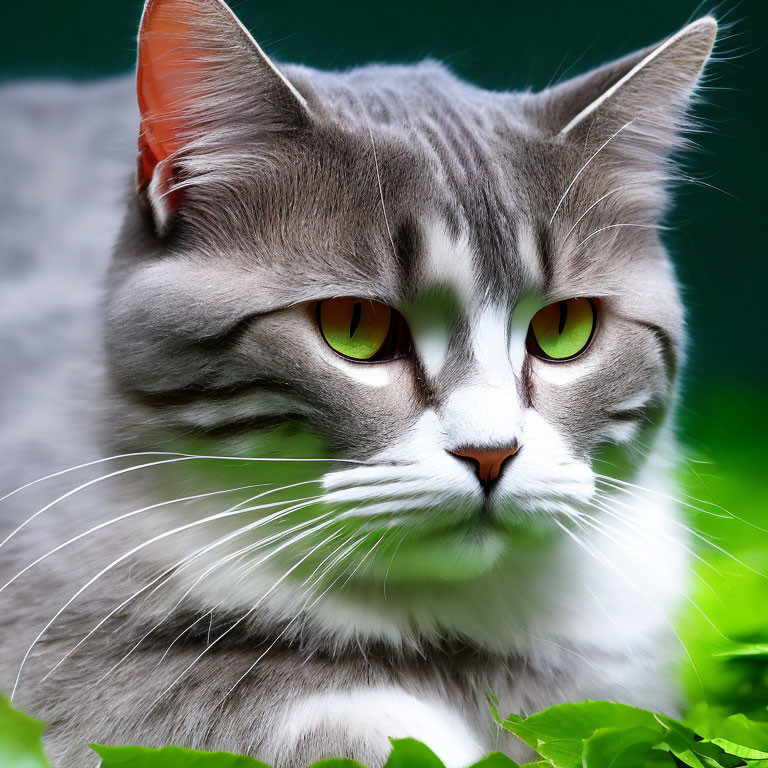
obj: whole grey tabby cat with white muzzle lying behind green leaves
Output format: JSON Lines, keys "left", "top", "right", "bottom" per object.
{"left": 0, "top": 0, "right": 717, "bottom": 768}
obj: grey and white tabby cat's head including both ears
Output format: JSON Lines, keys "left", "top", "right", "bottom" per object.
{"left": 100, "top": 0, "right": 717, "bottom": 580}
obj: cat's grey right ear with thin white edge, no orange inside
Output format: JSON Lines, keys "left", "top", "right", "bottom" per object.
{"left": 538, "top": 16, "right": 717, "bottom": 155}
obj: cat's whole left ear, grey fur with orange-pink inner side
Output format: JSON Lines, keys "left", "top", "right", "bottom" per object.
{"left": 136, "top": 0, "right": 308, "bottom": 231}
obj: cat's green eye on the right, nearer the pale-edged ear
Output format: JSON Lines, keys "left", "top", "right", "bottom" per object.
{"left": 527, "top": 299, "right": 596, "bottom": 360}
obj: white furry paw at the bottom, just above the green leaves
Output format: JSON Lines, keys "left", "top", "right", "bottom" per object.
{"left": 272, "top": 686, "right": 488, "bottom": 768}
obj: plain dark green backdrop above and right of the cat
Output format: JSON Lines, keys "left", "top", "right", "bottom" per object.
{"left": 0, "top": 0, "right": 768, "bottom": 427}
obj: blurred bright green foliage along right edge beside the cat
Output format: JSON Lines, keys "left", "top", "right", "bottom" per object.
{"left": 680, "top": 388, "right": 768, "bottom": 731}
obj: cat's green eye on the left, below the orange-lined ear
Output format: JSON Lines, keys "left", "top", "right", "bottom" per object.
{"left": 317, "top": 298, "right": 409, "bottom": 362}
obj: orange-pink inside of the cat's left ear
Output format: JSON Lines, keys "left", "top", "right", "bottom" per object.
{"left": 136, "top": 0, "right": 204, "bottom": 202}
